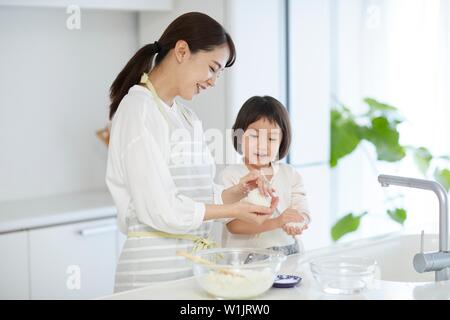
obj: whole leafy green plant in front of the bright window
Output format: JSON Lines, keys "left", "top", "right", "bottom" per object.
{"left": 330, "top": 98, "right": 450, "bottom": 241}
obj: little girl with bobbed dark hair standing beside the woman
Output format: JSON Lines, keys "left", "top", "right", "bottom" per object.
{"left": 222, "top": 96, "right": 310, "bottom": 254}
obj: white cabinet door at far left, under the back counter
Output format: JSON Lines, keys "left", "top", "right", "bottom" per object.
{"left": 0, "top": 231, "right": 29, "bottom": 300}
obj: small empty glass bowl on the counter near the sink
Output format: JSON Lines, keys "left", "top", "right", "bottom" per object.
{"left": 310, "top": 256, "right": 377, "bottom": 294}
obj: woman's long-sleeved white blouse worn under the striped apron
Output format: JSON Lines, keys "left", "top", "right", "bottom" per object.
{"left": 106, "top": 85, "right": 223, "bottom": 233}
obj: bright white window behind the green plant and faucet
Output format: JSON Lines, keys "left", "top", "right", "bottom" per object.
{"left": 331, "top": 0, "right": 450, "bottom": 237}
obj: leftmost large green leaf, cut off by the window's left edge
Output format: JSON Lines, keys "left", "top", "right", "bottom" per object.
{"left": 330, "top": 109, "right": 361, "bottom": 168}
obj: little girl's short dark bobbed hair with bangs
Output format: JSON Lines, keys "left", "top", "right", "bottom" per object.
{"left": 232, "top": 96, "right": 292, "bottom": 159}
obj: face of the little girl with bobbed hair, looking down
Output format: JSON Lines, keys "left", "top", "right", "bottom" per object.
{"left": 242, "top": 118, "right": 283, "bottom": 167}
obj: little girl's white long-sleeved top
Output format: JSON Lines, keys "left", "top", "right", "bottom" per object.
{"left": 221, "top": 163, "right": 310, "bottom": 248}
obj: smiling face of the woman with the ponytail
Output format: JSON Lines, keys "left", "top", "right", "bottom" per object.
{"left": 175, "top": 41, "right": 230, "bottom": 100}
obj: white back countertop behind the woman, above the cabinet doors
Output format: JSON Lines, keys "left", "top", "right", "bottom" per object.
{"left": 0, "top": 190, "right": 116, "bottom": 234}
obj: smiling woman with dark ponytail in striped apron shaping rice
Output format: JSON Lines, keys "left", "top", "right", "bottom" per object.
{"left": 106, "top": 12, "right": 278, "bottom": 292}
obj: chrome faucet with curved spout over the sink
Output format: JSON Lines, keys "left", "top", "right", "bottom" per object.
{"left": 378, "top": 174, "right": 450, "bottom": 281}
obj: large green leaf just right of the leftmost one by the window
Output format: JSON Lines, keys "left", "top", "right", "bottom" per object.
{"left": 361, "top": 117, "right": 406, "bottom": 162}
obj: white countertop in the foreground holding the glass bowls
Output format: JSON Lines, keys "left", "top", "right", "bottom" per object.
{"left": 100, "top": 251, "right": 450, "bottom": 300}
